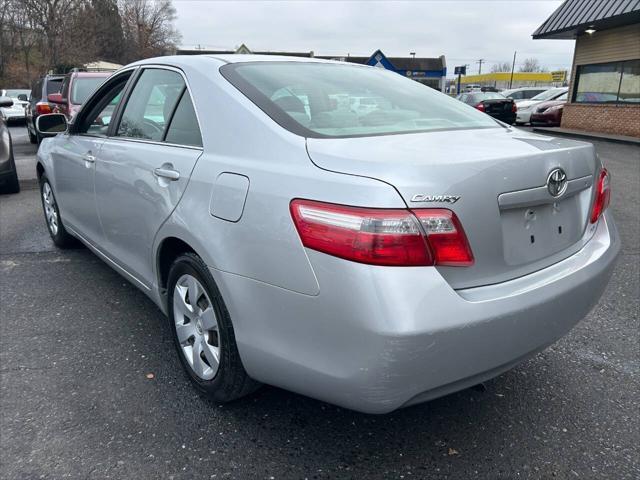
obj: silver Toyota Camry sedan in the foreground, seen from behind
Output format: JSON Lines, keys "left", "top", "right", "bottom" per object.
{"left": 37, "top": 55, "right": 620, "bottom": 413}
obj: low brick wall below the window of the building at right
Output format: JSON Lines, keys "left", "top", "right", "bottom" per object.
{"left": 560, "top": 103, "right": 640, "bottom": 138}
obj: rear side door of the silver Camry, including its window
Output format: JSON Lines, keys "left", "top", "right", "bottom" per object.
{"left": 95, "top": 67, "right": 206, "bottom": 286}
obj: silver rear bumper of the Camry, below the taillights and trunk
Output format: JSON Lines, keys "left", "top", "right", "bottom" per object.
{"left": 212, "top": 213, "right": 620, "bottom": 413}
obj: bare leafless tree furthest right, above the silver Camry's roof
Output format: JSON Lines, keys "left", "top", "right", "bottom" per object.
{"left": 120, "top": 0, "right": 180, "bottom": 62}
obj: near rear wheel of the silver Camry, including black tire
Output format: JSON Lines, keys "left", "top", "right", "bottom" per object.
{"left": 167, "top": 253, "right": 260, "bottom": 403}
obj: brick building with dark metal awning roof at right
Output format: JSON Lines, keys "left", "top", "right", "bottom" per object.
{"left": 533, "top": 0, "right": 640, "bottom": 137}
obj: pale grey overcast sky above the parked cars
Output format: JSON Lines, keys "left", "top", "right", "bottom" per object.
{"left": 173, "top": 0, "right": 574, "bottom": 76}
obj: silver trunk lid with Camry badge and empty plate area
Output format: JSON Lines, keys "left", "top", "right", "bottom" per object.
{"left": 307, "top": 128, "right": 599, "bottom": 289}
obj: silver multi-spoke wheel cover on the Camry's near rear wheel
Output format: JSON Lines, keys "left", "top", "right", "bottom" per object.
{"left": 173, "top": 274, "right": 220, "bottom": 380}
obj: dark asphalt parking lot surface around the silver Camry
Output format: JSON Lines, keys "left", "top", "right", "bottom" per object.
{"left": 0, "top": 126, "right": 640, "bottom": 479}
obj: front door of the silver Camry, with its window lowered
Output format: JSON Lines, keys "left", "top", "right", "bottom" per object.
{"left": 51, "top": 72, "right": 131, "bottom": 246}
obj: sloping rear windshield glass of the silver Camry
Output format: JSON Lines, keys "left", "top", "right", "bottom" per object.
{"left": 220, "top": 62, "right": 498, "bottom": 138}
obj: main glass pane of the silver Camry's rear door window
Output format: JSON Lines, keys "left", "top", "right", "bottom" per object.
{"left": 117, "top": 68, "right": 185, "bottom": 142}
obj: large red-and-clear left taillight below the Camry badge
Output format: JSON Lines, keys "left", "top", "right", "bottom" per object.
{"left": 291, "top": 200, "right": 473, "bottom": 266}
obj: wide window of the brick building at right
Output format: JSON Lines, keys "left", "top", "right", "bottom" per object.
{"left": 573, "top": 60, "right": 640, "bottom": 104}
